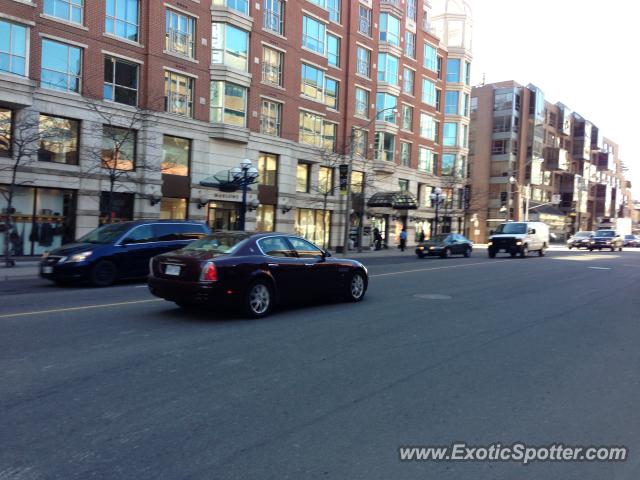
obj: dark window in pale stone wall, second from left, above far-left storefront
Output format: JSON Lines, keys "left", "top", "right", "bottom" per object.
{"left": 38, "top": 114, "right": 80, "bottom": 165}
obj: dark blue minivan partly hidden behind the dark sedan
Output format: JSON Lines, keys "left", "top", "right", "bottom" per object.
{"left": 40, "top": 220, "right": 211, "bottom": 287}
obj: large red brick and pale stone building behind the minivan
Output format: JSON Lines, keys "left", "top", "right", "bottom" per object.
{"left": 0, "top": 0, "right": 471, "bottom": 255}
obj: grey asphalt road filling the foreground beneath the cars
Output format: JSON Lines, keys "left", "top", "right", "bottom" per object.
{"left": 0, "top": 250, "right": 640, "bottom": 480}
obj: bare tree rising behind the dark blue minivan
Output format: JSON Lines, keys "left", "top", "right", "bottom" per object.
{"left": 81, "top": 100, "right": 160, "bottom": 223}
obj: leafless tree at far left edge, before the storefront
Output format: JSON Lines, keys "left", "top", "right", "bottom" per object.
{"left": 0, "top": 110, "right": 50, "bottom": 267}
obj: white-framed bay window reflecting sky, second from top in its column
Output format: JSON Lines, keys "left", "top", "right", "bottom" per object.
{"left": 211, "top": 22, "right": 249, "bottom": 72}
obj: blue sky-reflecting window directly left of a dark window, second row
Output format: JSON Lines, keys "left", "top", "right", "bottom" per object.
{"left": 40, "top": 39, "right": 82, "bottom": 93}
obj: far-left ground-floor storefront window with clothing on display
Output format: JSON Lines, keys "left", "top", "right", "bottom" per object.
{"left": 0, "top": 185, "right": 76, "bottom": 256}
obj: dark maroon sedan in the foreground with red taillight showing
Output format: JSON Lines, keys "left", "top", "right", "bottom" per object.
{"left": 149, "top": 232, "right": 368, "bottom": 318}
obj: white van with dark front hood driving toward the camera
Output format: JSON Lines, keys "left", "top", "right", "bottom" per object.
{"left": 487, "top": 222, "right": 549, "bottom": 258}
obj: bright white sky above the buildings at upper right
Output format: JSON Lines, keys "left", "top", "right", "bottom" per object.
{"left": 466, "top": 0, "right": 640, "bottom": 200}
